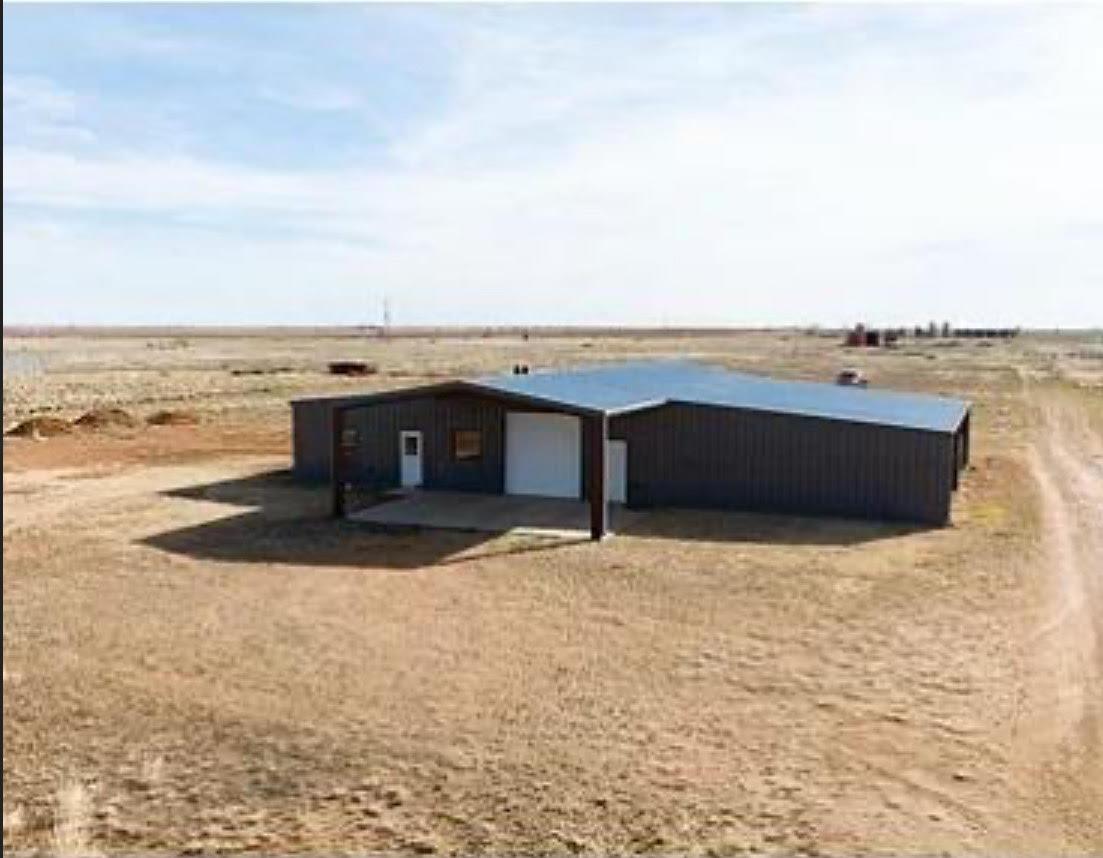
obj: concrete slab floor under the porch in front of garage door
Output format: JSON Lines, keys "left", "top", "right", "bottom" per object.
{"left": 349, "top": 491, "right": 641, "bottom": 537}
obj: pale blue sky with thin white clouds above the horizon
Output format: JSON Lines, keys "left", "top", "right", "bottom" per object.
{"left": 3, "top": 3, "right": 1103, "bottom": 328}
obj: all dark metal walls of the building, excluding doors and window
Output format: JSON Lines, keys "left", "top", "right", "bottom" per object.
{"left": 293, "top": 394, "right": 967, "bottom": 524}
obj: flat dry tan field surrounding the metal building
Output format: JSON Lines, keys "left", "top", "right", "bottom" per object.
{"left": 3, "top": 332, "right": 1103, "bottom": 855}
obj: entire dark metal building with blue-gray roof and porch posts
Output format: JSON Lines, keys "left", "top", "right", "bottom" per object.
{"left": 292, "top": 361, "right": 970, "bottom": 538}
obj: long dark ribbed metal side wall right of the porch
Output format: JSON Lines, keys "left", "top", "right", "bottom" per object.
{"left": 610, "top": 405, "right": 955, "bottom": 524}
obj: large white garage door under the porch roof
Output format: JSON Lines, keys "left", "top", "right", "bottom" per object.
{"left": 505, "top": 411, "right": 582, "bottom": 497}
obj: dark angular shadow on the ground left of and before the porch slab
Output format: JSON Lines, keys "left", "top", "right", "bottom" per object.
{"left": 140, "top": 471, "right": 588, "bottom": 570}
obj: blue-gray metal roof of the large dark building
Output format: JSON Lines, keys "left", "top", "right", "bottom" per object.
{"left": 467, "top": 361, "right": 968, "bottom": 432}
